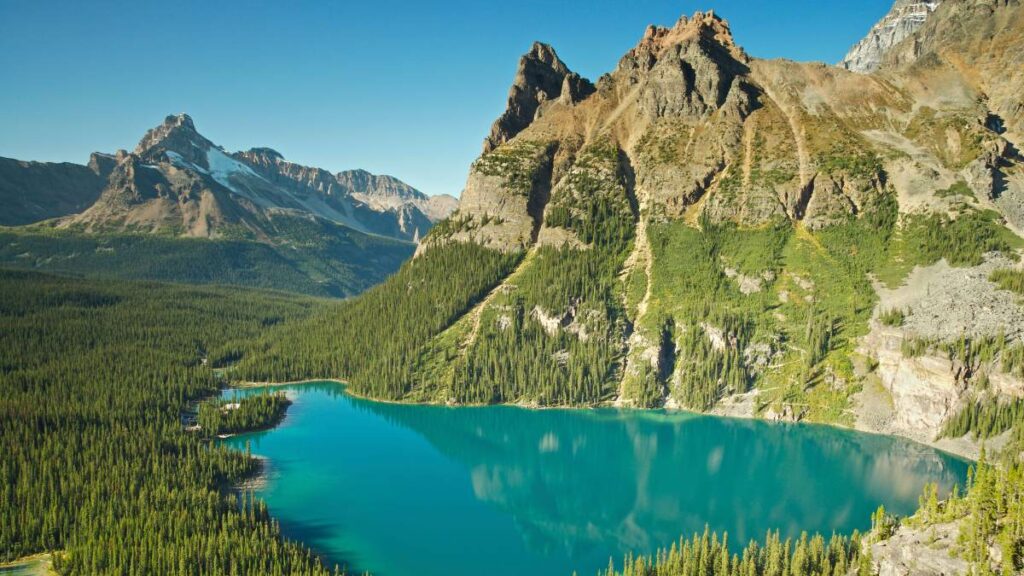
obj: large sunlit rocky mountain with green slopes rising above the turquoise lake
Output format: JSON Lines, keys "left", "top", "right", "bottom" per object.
{"left": 240, "top": 0, "right": 1024, "bottom": 461}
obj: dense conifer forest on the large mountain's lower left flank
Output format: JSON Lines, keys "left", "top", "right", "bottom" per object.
{"left": 225, "top": 242, "right": 521, "bottom": 400}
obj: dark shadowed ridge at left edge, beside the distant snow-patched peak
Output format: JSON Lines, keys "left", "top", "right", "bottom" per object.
{"left": 0, "top": 154, "right": 114, "bottom": 225}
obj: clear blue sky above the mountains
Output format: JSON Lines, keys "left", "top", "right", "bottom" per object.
{"left": 0, "top": 0, "right": 892, "bottom": 195}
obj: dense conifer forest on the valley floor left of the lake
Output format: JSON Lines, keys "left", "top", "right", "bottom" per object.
{"left": 0, "top": 272, "right": 348, "bottom": 576}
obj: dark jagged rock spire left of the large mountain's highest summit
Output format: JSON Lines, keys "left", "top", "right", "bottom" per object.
{"left": 483, "top": 42, "right": 594, "bottom": 154}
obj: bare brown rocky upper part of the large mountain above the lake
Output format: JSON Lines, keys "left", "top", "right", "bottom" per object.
{"left": 442, "top": 12, "right": 906, "bottom": 241}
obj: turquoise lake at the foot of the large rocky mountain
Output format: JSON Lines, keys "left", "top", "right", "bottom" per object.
{"left": 225, "top": 383, "right": 968, "bottom": 576}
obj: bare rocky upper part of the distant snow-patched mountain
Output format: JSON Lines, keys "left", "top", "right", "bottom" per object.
{"left": 56, "top": 114, "right": 454, "bottom": 241}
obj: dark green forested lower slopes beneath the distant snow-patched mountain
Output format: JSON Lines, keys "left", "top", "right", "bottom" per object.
{"left": 0, "top": 216, "right": 415, "bottom": 297}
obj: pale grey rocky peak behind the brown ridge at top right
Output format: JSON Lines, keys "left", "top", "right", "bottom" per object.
{"left": 840, "top": 0, "right": 941, "bottom": 73}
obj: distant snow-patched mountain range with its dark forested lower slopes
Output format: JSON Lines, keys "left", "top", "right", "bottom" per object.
{"left": 0, "top": 114, "right": 458, "bottom": 295}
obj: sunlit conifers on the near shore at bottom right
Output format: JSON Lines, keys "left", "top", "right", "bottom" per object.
{"left": 598, "top": 451, "right": 1024, "bottom": 576}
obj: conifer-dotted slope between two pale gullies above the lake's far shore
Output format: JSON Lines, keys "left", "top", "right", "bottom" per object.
{"left": 447, "top": 241, "right": 625, "bottom": 405}
